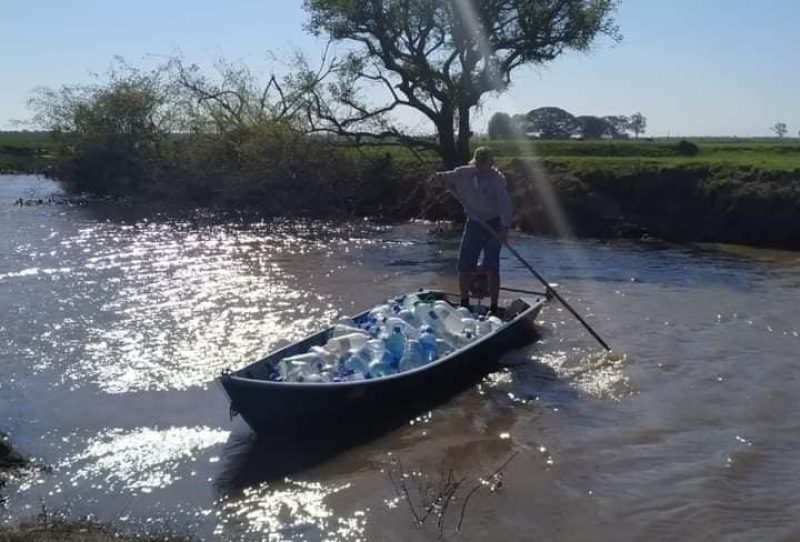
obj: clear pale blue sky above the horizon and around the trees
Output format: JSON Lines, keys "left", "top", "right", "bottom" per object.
{"left": 0, "top": 0, "right": 800, "bottom": 136}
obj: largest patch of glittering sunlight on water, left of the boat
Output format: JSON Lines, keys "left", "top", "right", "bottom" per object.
{"left": 46, "top": 224, "right": 366, "bottom": 393}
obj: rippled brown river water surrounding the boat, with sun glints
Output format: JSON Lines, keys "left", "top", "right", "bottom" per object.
{"left": 0, "top": 176, "right": 800, "bottom": 541}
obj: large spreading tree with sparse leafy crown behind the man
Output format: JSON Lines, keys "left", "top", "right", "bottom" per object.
{"left": 304, "top": 0, "right": 619, "bottom": 167}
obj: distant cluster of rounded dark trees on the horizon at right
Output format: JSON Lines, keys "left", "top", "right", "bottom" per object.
{"left": 488, "top": 107, "right": 647, "bottom": 139}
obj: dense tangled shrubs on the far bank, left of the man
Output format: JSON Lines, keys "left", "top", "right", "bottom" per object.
{"left": 32, "top": 75, "right": 428, "bottom": 217}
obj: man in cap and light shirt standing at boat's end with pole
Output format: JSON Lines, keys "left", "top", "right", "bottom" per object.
{"left": 434, "top": 147, "right": 513, "bottom": 313}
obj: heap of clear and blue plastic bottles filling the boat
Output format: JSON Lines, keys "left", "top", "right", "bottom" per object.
{"left": 272, "top": 293, "right": 502, "bottom": 383}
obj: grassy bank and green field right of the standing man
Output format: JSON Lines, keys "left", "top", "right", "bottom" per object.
{"left": 423, "top": 139, "right": 800, "bottom": 250}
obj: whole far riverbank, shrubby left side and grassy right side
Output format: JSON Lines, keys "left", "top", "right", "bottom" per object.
{"left": 0, "top": 133, "right": 800, "bottom": 249}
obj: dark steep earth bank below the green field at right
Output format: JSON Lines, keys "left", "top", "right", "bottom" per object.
{"left": 505, "top": 159, "right": 800, "bottom": 250}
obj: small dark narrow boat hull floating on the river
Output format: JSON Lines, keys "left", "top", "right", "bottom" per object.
{"left": 219, "top": 290, "right": 545, "bottom": 434}
